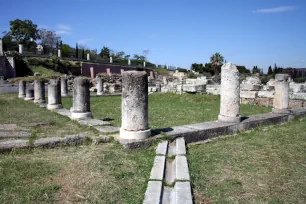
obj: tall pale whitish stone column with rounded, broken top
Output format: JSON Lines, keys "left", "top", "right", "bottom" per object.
{"left": 218, "top": 62, "right": 241, "bottom": 123}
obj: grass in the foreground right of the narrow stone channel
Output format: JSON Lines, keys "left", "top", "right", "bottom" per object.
{"left": 188, "top": 118, "right": 306, "bottom": 203}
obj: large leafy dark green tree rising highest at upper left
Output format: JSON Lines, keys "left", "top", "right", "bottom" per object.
{"left": 8, "top": 19, "right": 39, "bottom": 44}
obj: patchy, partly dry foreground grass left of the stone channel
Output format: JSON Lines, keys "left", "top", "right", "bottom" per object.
{"left": 0, "top": 143, "right": 154, "bottom": 204}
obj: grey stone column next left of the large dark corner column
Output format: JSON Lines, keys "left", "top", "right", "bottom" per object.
{"left": 71, "top": 77, "right": 92, "bottom": 120}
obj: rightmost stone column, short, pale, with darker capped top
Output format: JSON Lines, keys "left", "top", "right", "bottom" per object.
{"left": 272, "top": 74, "right": 290, "bottom": 113}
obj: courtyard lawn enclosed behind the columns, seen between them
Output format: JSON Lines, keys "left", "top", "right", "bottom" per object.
{"left": 63, "top": 93, "right": 271, "bottom": 129}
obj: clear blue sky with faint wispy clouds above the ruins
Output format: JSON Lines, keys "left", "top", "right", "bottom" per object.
{"left": 0, "top": 0, "right": 306, "bottom": 71}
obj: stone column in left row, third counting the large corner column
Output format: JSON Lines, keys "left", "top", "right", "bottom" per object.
{"left": 47, "top": 79, "right": 63, "bottom": 110}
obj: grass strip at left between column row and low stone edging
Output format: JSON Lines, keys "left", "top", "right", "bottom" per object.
{"left": 0, "top": 94, "right": 94, "bottom": 137}
